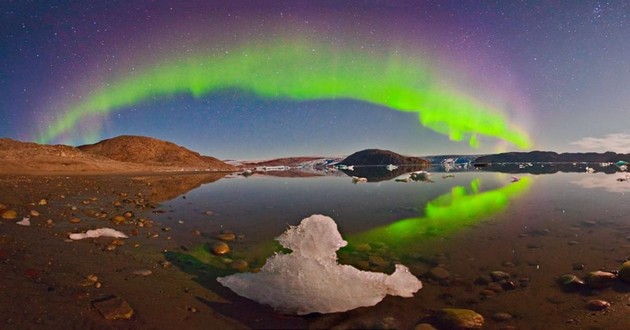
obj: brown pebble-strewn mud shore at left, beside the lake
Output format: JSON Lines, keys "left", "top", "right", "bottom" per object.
{"left": 0, "top": 175, "right": 243, "bottom": 329}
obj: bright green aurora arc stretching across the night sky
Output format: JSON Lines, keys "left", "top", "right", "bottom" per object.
{"left": 38, "top": 42, "right": 532, "bottom": 149}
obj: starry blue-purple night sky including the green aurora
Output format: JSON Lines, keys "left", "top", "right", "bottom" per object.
{"left": 0, "top": 0, "right": 630, "bottom": 159}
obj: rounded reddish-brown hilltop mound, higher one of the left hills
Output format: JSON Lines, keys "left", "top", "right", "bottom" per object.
{"left": 78, "top": 135, "right": 236, "bottom": 171}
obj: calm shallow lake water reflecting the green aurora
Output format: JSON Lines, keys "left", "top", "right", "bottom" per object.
{"left": 155, "top": 169, "right": 630, "bottom": 329}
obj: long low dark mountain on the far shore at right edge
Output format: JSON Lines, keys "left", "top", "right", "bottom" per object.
{"left": 475, "top": 151, "right": 630, "bottom": 164}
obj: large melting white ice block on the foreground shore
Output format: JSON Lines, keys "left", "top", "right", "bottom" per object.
{"left": 217, "top": 214, "right": 422, "bottom": 315}
